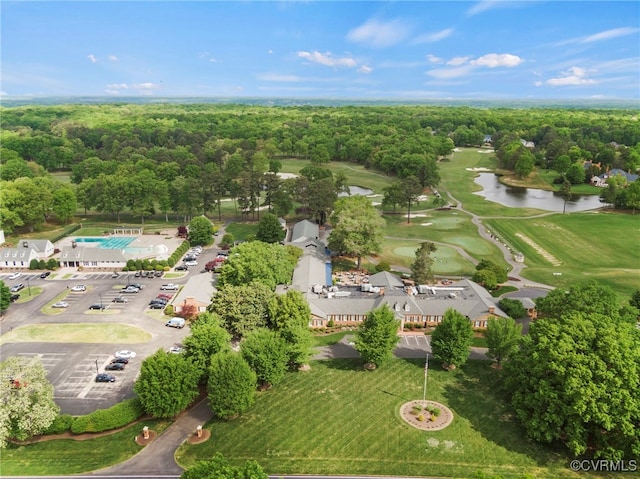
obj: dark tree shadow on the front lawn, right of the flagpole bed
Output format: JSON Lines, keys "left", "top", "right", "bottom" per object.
{"left": 443, "top": 361, "right": 568, "bottom": 466}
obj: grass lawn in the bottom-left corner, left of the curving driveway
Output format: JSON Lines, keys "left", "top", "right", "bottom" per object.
{"left": 0, "top": 419, "right": 170, "bottom": 477}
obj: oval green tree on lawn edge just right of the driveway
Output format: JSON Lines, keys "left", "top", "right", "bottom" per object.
{"left": 207, "top": 351, "right": 257, "bottom": 419}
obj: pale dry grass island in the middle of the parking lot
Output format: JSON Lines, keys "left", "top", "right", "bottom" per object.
{"left": 0, "top": 323, "right": 151, "bottom": 344}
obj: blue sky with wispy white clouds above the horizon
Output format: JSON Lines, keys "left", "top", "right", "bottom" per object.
{"left": 0, "top": 0, "right": 640, "bottom": 100}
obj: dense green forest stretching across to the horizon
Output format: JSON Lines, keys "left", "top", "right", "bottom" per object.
{"left": 0, "top": 104, "right": 640, "bottom": 232}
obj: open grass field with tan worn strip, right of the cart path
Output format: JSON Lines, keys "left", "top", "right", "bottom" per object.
{"left": 485, "top": 211, "right": 640, "bottom": 300}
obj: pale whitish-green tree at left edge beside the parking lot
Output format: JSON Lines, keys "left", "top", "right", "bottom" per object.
{"left": 0, "top": 356, "right": 60, "bottom": 447}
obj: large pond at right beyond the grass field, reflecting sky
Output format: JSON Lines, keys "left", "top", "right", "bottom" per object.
{"left": 474, "top": 173, "right": 602, "bottom": 212}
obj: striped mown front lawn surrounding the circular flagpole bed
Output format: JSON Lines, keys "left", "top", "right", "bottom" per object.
{"left": 176, "top": 359, "right": 604, "bottom": 478}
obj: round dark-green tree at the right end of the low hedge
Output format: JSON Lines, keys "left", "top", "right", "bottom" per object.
{"left": 133, "top": 350, "right": 200, "bottom": 417}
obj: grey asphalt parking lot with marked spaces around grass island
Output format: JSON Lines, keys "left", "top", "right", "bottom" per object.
{"left": 0, "top": 250, "right": 215, "bottom": 415}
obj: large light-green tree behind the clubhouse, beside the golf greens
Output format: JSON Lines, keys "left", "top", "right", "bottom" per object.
{"left": 328, "top": 196, "right": 385, "bottom": 269}
